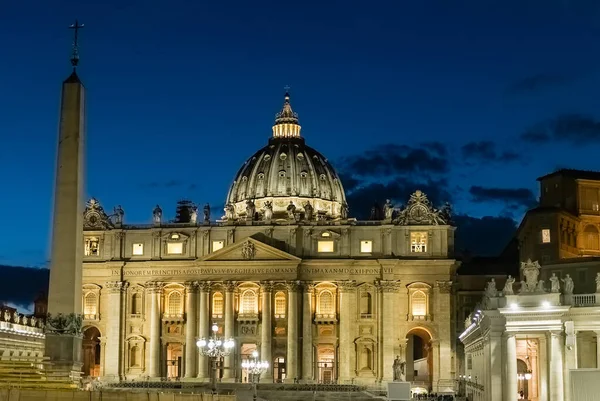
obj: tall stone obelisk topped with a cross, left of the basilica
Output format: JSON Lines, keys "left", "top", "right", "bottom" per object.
{"left": 45, "top": 21, "right": 85, "bottom": 377}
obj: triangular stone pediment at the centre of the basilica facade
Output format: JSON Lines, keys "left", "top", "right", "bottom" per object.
{"left": 201, "top": 237, "right": 301, "bottom": 262}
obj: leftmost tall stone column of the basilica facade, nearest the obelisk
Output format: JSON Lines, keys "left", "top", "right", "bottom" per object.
{"left": 104, "top": 281, "right": 129, "bottom": 381}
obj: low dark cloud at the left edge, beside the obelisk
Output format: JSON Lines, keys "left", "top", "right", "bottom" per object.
{"left": 0, "top": 265, "right": 50, "bottom": 309}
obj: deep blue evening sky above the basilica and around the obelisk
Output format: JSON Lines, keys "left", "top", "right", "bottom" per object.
{"left": 0, "top": 0, "right": 600, "bottom": 265}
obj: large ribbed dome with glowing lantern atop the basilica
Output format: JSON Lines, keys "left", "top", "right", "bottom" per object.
{"left": 226, "top": 93, "right": 347, "bottom": 220}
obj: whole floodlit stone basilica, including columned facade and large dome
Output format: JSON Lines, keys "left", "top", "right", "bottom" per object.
{"left": 82, "top": 94, "right": 457, "bottom": 392}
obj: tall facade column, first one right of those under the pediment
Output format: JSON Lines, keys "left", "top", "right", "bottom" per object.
{"left": 337, "top": 281, "right": 356, "bottom": 384}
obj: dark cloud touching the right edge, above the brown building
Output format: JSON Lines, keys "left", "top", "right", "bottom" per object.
{"left": 520, "top": 114, "right": 600, "bottom": 145}
